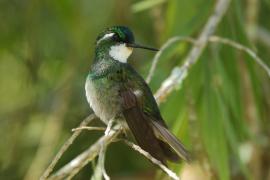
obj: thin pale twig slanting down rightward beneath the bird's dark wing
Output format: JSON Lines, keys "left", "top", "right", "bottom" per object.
{"left": 123, "top": 139, "right": 179, "bottom": 180}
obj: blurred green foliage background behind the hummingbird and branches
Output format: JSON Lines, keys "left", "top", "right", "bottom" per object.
{"left": 0, "top": 0, "right": 270, "bottom": 180}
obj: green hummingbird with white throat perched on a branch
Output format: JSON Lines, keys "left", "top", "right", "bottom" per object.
{"left": 85, "top": 26, "right": 190, "bottom": 165}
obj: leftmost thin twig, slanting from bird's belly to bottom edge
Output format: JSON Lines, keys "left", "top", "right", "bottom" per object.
{"left": 40, "top": 114, "right": 96, "bottom": 180}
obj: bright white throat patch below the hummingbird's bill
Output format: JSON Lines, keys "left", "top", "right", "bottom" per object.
{"left": 109, "top": 43, "right": 132, "bottom": 63}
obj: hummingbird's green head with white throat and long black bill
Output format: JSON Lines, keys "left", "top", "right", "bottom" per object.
{"left": 96, "top": 26, "right": 158, "bottom": 63}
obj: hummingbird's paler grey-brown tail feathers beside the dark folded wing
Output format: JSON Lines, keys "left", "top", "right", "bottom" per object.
{"left": 151, "top": 121, "right": 191, "bottom": 162}
